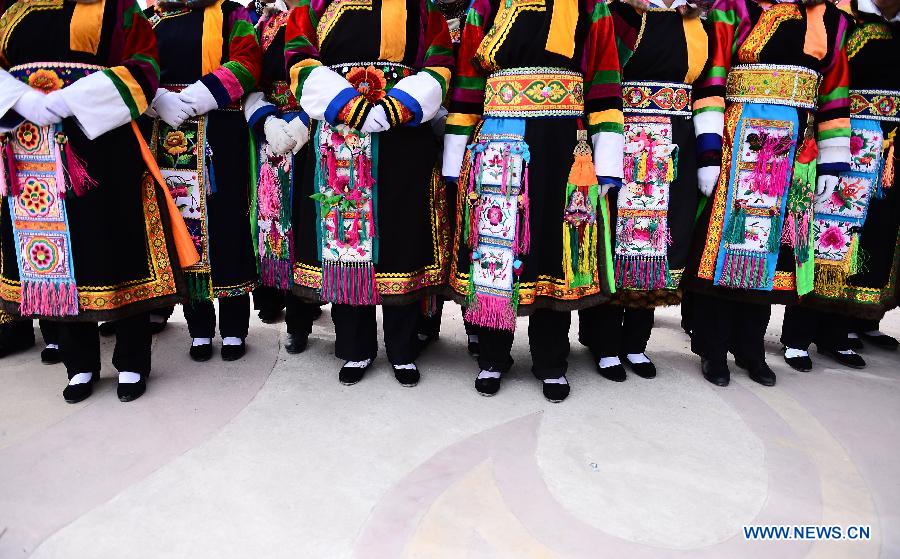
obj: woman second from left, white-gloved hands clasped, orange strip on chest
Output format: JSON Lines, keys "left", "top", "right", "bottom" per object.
{"left": 147, "top": 0, "right": 262, "bottom": 361}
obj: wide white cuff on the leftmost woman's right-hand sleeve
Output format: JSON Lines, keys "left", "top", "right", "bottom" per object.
{"left": 59, "top": 72, "right": 132, "bottom": 140}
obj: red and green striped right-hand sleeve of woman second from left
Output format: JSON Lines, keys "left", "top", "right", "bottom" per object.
{"left": 200, "top": 3, "right": 263, "bottom": 108}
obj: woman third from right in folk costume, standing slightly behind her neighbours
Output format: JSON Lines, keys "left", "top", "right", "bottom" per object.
{"left": 579, "top": 0, "right": 709, "bottom": 382}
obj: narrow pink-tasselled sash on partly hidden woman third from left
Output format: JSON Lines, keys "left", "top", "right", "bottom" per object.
{"left": 256, "top": 142, "right": 294, "bottom": 291}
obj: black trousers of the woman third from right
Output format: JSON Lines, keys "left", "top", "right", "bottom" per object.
{"left": 578, "top": 305, "right": 654, "bottom": 358}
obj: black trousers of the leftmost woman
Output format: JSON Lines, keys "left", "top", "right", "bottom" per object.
{"left": 57, "top": 313, "right": 152, "bottom": 378}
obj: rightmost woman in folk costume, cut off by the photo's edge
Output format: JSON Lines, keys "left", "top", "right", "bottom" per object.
{"left": 781, "top": 0, "right": 900, "bottom": 371}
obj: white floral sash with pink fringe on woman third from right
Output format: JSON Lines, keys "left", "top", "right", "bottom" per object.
{"left": 615, "top": 115, "right": 678, "bottom": 290}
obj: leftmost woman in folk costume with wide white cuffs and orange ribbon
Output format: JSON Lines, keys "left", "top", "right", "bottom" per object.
{"left": 0, "top": 0, "right": 197, "bottom": 402}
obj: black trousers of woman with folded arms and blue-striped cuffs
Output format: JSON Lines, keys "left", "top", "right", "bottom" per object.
{"left": 331, "top": 302, "right": 420, "bottom": 365}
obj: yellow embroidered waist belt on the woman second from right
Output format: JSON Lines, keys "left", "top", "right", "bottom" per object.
{"left": 725, "top": 64, "right": 820, "bottom": 109}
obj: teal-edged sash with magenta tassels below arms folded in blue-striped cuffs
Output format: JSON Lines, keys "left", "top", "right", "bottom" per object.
{"left": 311, "top": 122, "right": 380, "bottom": 305}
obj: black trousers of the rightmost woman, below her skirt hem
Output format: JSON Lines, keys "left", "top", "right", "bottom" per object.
{"left": 781, "top": 305, "right": 850, "bottom": 351}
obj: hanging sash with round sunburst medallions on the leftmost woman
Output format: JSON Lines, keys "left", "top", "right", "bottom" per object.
{"left": 4, "top": 126, "right": 78, "bottom": 316}
